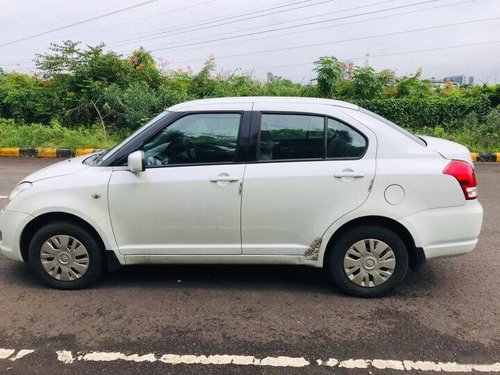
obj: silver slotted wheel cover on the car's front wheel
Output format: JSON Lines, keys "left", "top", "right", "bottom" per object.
{"left": 40, "top": 234, "right": 90, "bottom": 281}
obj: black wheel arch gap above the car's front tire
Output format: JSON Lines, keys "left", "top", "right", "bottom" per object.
{"left": 19, "top": 212, "right": 106, "bottom": 262}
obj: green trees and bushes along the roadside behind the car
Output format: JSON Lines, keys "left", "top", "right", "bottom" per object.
{"left": 0, "top": 41, "right": 500, "bottom": 151}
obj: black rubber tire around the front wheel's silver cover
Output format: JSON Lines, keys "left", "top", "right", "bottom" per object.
{"left": 28, "top": 222, "right": 105, "bottom": 290}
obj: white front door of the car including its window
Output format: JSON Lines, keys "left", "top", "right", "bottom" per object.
{"left": 109, "top": 112, "right": 250, "bottom": 256}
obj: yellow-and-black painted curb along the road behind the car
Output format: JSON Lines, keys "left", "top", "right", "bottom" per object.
{"left": 0, "top": 147, "right": 500, "bottom": 163}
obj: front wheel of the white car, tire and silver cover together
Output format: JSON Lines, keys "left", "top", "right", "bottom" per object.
{"left": 29, "top": 222, "right": 104, "bottom": 289}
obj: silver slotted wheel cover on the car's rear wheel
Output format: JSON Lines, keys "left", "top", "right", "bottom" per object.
{"left": 344, "top": 238, "right": 396, "bottom": 288}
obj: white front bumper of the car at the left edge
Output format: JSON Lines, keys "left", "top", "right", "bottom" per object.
{"left": 0, "top": 209, "right": 33, "bottom": 261}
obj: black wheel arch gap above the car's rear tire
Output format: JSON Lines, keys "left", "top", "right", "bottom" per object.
{"left": 323, "top": 215, "right": 425, "bottom": 271}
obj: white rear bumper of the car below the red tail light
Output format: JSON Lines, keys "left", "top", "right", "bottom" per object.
{"left": 400, "top": 200, "right": 483, "bottom": 259}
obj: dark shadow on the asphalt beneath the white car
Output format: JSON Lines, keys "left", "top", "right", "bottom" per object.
{"left": 1, "top": 261, "right": 439, "bottom": 297}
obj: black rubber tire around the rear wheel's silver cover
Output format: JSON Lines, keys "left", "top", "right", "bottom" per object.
{"left": 327, "top": 225, "right": 408, "bottom": 298}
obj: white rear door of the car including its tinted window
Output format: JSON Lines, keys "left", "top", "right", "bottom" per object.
{"left": 242, "top": 103, "right": 376, "bottom": 255}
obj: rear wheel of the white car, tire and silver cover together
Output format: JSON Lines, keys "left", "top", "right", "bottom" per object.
{"left": 328, "top": 226, "right": 408, "bottom": 297}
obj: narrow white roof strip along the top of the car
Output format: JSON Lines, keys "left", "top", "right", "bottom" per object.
{"left": 168, "top": 96, "right": 359, "bottom": 112}
